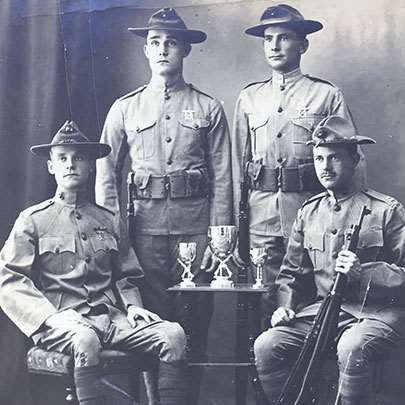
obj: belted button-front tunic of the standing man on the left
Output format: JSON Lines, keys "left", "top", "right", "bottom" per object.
{"left": 96, "top": 77, "right": 232, "bottom": 235}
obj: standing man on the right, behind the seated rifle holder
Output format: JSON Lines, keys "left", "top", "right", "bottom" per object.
{"left": 232, "top": 4, "right": 362, "bottom": 318}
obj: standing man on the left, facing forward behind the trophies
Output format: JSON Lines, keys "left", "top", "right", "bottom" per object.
{"left": 96, "top": 8, "right": 232, "bottom": 404}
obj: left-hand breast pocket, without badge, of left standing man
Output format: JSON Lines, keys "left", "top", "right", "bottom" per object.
{"left": 126, "top": 117, "right": 157, "bottom": 160}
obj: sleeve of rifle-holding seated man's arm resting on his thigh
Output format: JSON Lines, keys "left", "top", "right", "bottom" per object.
{"left": 276, "top": 211, "right": 316, "bottom": 310}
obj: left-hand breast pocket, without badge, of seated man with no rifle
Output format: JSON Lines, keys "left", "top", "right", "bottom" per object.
{"left": 38, "top": 235, "right": 76, "bottom": 274}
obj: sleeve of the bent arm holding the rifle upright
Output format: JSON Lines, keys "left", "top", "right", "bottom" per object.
{"left": 359, "top": 203, "right": 405, "bottom": 305}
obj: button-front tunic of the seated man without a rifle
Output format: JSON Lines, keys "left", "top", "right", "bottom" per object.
{"left": 0, "top": 195, "right": 142, "bottom": 336}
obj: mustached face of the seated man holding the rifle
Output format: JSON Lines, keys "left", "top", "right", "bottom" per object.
{"left": 313, "top": 145, "right": 358, "bottom": 192}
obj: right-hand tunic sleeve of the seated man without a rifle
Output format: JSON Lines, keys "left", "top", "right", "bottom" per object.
{"left": 114, "top": 215, "right": 143, "bottom": 308}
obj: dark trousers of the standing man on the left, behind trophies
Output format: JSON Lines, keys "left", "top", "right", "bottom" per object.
{"left": 132, "top": 234, "right": 213, "bottom": 405}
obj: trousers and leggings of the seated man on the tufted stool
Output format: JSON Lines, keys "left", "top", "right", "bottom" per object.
{"left": 35, "top": 307, "right": 186, "bottom": 405}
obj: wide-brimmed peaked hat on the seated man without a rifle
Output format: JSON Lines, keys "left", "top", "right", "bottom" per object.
{"left": 30, "top": 121, "right": 111, "bottom": 159}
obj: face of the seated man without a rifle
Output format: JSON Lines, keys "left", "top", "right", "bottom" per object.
{"left": 48, "top": 145, "right": 94, "bottom": 191}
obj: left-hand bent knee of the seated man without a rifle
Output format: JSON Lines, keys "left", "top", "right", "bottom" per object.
{"left": 71, "top": 326, "right": 101, "bottom": 367}
